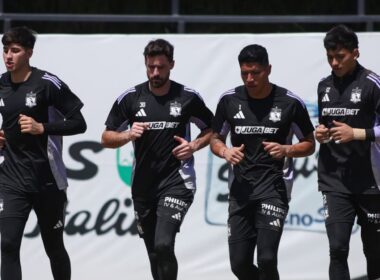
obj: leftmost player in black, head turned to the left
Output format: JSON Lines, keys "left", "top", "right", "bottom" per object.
{"left": 0, "top": 27, "right": 86, "bottom": 280}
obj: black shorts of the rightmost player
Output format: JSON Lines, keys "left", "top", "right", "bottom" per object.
{"left": 322, "top": 192, "right": 380, "bottom": 230}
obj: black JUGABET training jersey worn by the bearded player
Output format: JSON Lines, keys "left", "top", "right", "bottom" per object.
{"left": 105, "top": 81, "right": 213, "bottom": 201}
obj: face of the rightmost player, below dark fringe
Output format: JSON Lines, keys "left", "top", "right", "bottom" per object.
{"left": 327, "top": 48, "right": 359, "bottom": 77}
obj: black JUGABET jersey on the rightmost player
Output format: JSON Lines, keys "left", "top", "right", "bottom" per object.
{"left": 318, "top": 64, "right": 380, "bottom": 194}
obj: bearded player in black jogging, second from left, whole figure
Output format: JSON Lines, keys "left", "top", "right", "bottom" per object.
{"left": 102, "top": 39, "right": 213, "bottom": 280}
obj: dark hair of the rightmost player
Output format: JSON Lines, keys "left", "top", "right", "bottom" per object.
{"left": 323, "top": 24, "right": 359, "bottom": 51}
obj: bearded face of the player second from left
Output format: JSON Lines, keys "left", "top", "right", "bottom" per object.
{"left": 145, "top": 55, "right": 174, "bottom": 88}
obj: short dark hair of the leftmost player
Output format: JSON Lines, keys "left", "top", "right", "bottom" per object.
{"left": 1, "top": 26, "right": 37, "bottom": 49}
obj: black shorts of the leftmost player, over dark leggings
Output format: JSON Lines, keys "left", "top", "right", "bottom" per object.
{"left": 0, "top": 185, "right": 67, "bottom": 222}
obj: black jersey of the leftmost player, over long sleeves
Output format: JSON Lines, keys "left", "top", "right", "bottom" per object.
{"left": 0, "top": 68, "right": 83, "bottom": 192}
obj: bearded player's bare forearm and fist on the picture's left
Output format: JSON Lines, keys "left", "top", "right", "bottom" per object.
{"left": 101, "top": 122, "right": 148, "bottom": 148}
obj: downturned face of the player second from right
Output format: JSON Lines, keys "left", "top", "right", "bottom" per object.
{"left": 240, "top": 62, "right": 271, "bottom": 95}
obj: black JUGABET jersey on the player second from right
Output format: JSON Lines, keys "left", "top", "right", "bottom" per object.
{"left": 212, "top": 85, "right": 314, "bottom": 200}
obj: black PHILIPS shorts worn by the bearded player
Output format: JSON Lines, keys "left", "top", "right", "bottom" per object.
{"left": 133, "top": 196, "right": 193, "bottom": 237}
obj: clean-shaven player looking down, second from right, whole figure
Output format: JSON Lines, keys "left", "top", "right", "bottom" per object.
{"left": 210, "top": 44, "right": 315, "bottom": 280}
